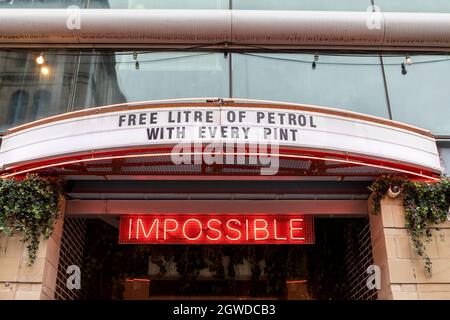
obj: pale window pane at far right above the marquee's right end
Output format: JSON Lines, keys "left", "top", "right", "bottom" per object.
{"left": 384, "top": 56, "right": 450, "bottom": 135}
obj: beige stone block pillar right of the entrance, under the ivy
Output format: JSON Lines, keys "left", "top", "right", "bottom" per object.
{"left": 369, "top": 197, "right": 450, "bottom": 300}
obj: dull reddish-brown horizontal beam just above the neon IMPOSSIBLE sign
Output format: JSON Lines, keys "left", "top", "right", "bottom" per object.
{"left": 65, "top": 200, "right": 367, "bottom": 218}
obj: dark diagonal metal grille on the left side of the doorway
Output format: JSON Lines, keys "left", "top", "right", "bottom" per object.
{"left": 55, "top": 218, "right": 86, "bottom": 300}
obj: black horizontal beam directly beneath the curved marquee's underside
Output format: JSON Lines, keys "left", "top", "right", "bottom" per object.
{"left": 66, "top": 177, "right": 371, "bottom": 195}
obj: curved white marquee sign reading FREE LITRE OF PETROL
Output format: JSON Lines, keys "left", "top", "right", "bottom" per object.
{"left": 0, "top": 102, "right": 441, "bottom": 178}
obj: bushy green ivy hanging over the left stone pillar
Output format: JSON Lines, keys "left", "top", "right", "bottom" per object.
{"left": 0, "top": 174, "right": 62, "bottom": 265}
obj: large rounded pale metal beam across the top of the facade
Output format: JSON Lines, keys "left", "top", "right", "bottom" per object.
{"left": 0, "top": 9, "right": 450, "bottom": 51}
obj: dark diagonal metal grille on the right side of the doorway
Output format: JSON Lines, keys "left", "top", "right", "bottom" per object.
{"left": 345, "top": 220, "right": 377, "bottom": 300}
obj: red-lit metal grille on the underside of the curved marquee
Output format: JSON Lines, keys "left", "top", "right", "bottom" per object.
{"left": 14, "top": 147, "right": 414, "bottom": 177}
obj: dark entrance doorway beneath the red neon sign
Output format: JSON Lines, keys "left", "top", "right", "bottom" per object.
{"left": 53, "top": 218, "right": 376, "bottom": 300}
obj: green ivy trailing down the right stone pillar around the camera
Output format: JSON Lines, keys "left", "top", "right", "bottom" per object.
{"left": 370, "top": 175, "right": 450, "bottom": 275}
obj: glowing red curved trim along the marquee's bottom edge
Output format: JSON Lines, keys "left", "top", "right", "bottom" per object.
{"left": 0, "top": 147, "right": 440, "bottom": 181}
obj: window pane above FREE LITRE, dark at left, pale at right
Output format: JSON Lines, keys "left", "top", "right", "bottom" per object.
{"left": 75, "top": 52, "right": 229, "bottom": 108}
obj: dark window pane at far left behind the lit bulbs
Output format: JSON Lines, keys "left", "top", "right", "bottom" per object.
{"left": 0, "top": 51, "right": 75, "bottom": 131}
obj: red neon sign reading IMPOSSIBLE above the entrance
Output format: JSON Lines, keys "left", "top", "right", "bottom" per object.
{"left": 119, "top": 214, "right": 314, "bottom": 244}
